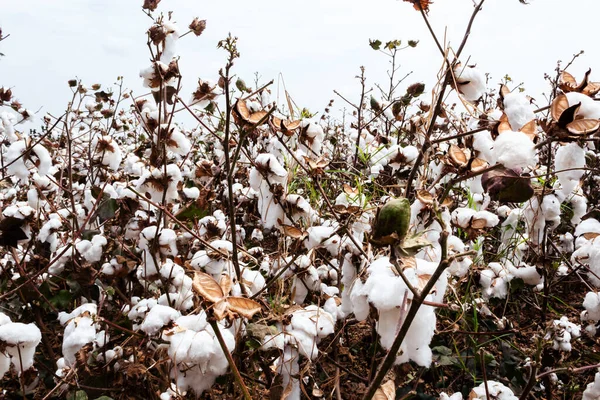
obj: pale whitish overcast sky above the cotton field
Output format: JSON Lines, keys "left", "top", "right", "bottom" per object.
{"left": 0, "top": 0, "right": 600, "bottom": 123}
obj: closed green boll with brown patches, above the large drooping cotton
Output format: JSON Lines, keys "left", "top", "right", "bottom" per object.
{"left": 373, "top": 198, "right": 410, "bottom": 244}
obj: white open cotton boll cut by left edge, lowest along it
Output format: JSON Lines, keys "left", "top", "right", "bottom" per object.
{"left": 0, "top": 322, "right": 42, "bottom": 378}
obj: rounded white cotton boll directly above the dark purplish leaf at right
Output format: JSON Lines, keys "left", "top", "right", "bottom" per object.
{"left": 493, "top": 131, "right": 537, "bottom": 169}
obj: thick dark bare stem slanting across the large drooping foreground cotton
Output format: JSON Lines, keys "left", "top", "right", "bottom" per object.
{"left": 363, "top": 231, "right": 450, "bottom": 400}
